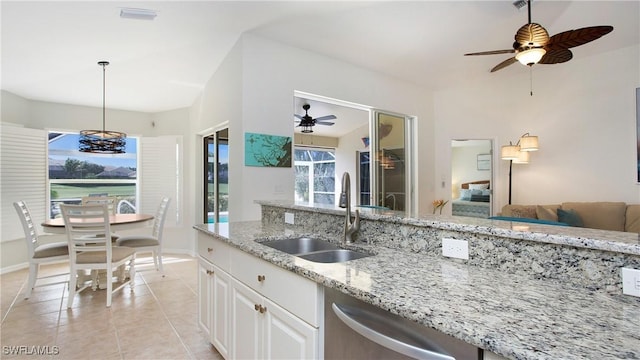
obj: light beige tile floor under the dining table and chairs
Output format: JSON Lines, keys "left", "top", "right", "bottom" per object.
{"left": 0, "top": 254, "right": 222, "bottom": 360}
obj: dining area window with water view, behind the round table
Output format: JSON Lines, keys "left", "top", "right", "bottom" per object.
{"left": 48, "top": 132, "right": 138, "bottom": 218}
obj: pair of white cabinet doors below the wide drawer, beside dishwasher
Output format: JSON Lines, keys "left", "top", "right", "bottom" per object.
{"left": 231, "top": 280, "right": 319, "bottom": 359}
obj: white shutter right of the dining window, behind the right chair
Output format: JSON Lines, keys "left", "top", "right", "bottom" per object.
{"left": 138, "top": 136, "right": 182, "bottom": 227}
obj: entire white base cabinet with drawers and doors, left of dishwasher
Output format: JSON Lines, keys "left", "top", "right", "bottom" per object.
{"left": 198, "top": 234, "right": 323, "bottom": 359}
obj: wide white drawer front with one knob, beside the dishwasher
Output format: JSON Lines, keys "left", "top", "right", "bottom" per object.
{"left": 231, "top": 252, "right": 320, "bottom": 327}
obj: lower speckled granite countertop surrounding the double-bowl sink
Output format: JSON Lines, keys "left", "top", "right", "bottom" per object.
{"left": 194, "top": 222, "right": 640, "bottom": 359}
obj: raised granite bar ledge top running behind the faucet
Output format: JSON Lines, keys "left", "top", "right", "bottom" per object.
{"left": 256, "top": 200, "right": 640, "bottom": 255}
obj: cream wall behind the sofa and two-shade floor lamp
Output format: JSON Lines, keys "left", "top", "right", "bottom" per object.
{"left": 433, "top": 45, "right": 640, "bottom": 211}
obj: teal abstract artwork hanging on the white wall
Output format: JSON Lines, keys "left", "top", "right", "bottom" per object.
{"left": 244, "top": 133, "right": 292, "bottom": 167}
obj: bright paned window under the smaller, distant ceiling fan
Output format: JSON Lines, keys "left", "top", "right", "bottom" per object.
{"left": 294, "top": 147, "right": 336, "bottom": 205}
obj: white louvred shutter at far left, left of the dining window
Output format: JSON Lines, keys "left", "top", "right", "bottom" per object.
{"left": 0, "top": 124, "right": 48, "bottom": 242}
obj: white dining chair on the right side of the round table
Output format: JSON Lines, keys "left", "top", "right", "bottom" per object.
{"left": 116, "top": 197, "right": 171, "bottom": 274}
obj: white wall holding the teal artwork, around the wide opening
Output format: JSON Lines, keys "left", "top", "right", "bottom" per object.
{"left": 210, "top": 35, "right": 433, "bottom": 220}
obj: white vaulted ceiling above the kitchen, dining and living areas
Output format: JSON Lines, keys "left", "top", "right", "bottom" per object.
{"left": 0, "top": 0, "right": 640, "bottom": 122}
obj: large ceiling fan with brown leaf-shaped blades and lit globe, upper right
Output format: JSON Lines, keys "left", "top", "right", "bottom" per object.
{"left": 464, "top": 0, "right": 613, "bottom": 72}
